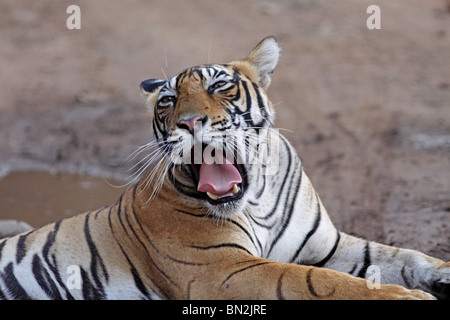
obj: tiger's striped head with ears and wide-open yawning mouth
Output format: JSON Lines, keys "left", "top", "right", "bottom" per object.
{"left": 140, "top": 37, "right": 280, "bottom": 216}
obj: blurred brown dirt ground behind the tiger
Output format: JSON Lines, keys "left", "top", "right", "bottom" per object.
{"left": 0, "top": 0, "right": 450, "bottom": 260}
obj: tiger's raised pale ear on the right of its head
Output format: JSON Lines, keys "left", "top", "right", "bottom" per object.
{"left": 245, "top": 37, "right": 281, "bottom": 89}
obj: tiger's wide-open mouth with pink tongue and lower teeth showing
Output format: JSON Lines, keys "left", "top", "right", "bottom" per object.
{"left": 190, "top": 146, "right": 244, "bottom": 204}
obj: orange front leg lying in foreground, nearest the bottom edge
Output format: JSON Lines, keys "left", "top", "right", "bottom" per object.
{"left": 189, "top": 257, "right": 433, "bottom": 300}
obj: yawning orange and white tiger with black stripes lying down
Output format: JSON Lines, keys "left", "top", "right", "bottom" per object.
{"left": 0, "top": 37, "right": 450, "bottom": 300}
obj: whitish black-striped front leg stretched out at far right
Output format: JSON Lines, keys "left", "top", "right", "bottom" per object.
{"left": 324, "top": 232, "right": 450, "bottom": 299}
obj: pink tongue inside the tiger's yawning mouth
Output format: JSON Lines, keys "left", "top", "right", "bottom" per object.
{"left": 197, "top": 154, "right": 242, "bottom": 196}
